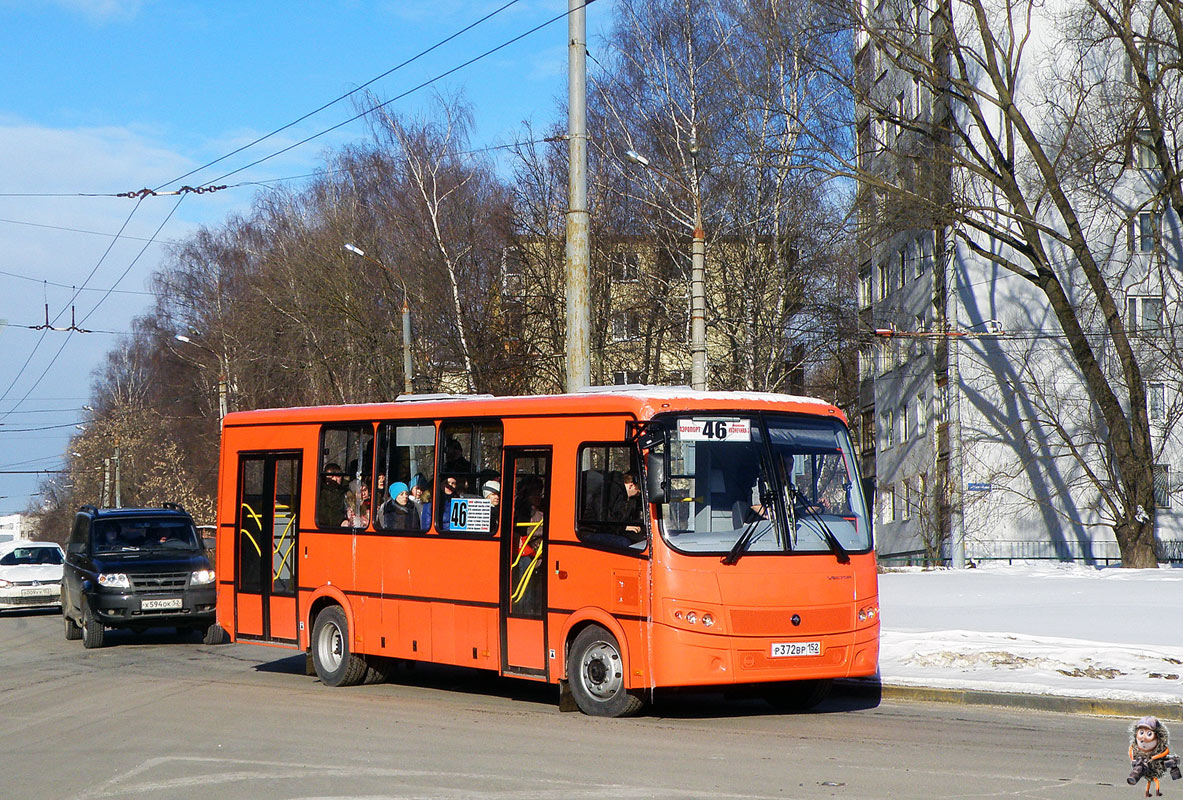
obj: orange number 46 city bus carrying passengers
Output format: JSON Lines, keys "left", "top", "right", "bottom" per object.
{"left": 216, "top": 387, "right": 879, "bottom": 716}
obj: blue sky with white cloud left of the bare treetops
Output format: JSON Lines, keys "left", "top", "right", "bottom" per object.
{"left": 0, "top": 0, "right": 612, "bottom": 514}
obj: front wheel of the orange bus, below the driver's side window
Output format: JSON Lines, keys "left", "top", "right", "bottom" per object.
{"left": 567, "top": 625, "right": 645, "bottom": 717}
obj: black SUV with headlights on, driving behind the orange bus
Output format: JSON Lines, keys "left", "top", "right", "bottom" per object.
{"left": 62, "top": 503, "right": 222, "bottom": 647}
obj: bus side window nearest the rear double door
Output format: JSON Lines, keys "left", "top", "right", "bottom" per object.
{"left": 316, "top": 422, "right": 374, "bottom": 528}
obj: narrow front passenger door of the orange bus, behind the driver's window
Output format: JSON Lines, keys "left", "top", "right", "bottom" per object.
{"left": 500, "top": 447, "right": 551, "bottom": 677}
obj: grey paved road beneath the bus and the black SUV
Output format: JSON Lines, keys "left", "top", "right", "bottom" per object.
{"left": 0, "top": 613, "right": 1135, "bottom": 800}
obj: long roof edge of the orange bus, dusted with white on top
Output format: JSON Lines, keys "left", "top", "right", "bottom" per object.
{"left": 225, "top": 386, "right": 846, "bottom": 427}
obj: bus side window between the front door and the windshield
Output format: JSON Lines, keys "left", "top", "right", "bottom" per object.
{"left": 575, "top": 444, "right": 645, "bottom": 550}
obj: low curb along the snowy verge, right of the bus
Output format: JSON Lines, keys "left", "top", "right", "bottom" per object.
{"left": 834, "top": 679, "right": 1183, "bottom": 722}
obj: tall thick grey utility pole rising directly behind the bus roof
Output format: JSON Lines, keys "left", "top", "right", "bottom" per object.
{"left": 567, "top": 0, "right": 592, "bottom": 392}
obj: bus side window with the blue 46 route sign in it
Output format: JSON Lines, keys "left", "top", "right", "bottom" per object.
{"left": 432, "top": 419, "right": 504, "bottom": 533}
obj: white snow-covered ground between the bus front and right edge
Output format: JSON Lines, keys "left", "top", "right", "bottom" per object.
{"left": 879, "top": 563, "right": 1183, "bottom": 703}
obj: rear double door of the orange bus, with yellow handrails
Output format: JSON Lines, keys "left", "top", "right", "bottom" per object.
{"left": 234, "top": 453, "right": 300, "bottom": 644}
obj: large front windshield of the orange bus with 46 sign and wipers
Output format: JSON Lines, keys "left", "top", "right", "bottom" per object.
{"left": 661, "top": 413, "right": 871, "bottom": 563}
